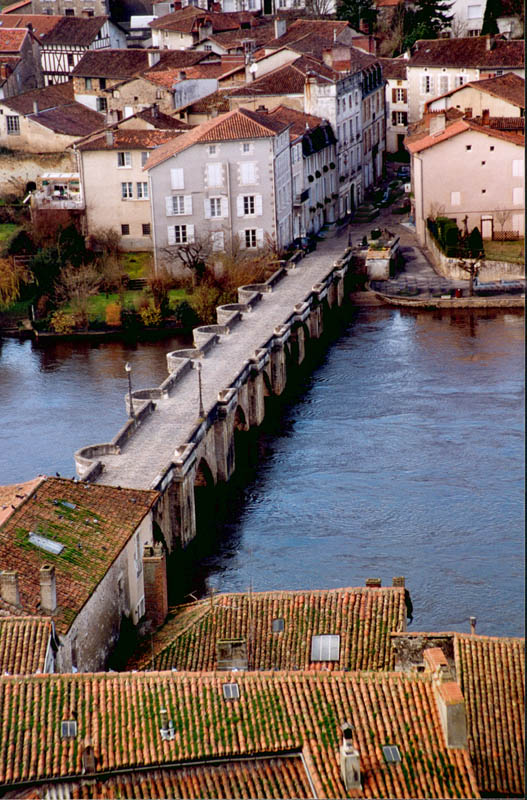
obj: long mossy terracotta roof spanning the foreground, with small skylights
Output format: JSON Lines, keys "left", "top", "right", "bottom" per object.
{"left": 0, "top": 672, "right": 478, "bottom": 798}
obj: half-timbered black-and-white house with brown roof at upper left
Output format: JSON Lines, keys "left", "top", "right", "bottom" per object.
{"left": 41, "top": 17, "right": 126, "bottom": 85}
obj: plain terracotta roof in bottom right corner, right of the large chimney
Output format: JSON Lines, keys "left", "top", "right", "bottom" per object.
{"left": 454, "top": 634, "right": 525, "bottom": 797}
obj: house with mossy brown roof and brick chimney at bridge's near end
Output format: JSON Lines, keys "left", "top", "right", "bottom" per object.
{"left": 0, "top": 478, "right": 166, "bottom": 672}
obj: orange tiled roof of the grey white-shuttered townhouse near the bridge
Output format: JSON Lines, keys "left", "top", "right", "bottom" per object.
{"left": 145, "top": 108, "right": 287, "bottom": 169}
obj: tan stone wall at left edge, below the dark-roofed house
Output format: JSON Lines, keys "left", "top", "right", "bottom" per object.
{"left": 0, "top": 150, "right": 76, "bottom": 197}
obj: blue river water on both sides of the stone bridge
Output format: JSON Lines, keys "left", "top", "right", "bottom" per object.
{"left": 0, "top": 308, "right": 524, "bottom": 636}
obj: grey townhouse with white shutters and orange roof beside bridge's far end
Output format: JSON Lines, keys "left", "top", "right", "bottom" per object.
{"left": 145, "top": 109, "right": 292, "bottom": 264}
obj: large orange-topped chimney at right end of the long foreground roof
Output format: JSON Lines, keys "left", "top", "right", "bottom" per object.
{"left": 423, "top": 647, "right": 467, "bottom": 747}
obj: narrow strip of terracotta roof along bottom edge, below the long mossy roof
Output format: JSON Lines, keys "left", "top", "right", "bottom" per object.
{"left": 16, "top": 753, "right": 314, "bottom": 800}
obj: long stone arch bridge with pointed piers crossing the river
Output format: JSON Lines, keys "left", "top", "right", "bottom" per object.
{"left": 75, "top": 239, "right": 351, "bottom": 550}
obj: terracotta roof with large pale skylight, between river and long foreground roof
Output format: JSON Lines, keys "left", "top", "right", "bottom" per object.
{"left": 129, "top": 588, "right": 406, "bottom": 671}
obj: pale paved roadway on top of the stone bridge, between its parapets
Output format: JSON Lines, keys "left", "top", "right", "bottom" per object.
{"left": 81, "top": 236, "right": 347, "bottom": 489}
